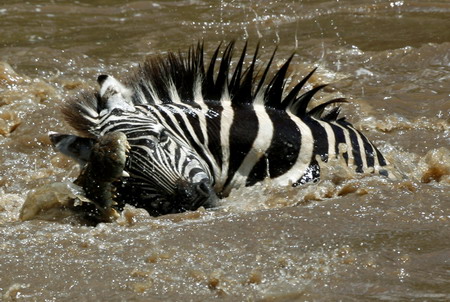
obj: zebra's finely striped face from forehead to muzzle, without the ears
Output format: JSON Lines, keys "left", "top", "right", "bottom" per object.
{"left": 114, "top": 115, "right": 215, "bottom": 215}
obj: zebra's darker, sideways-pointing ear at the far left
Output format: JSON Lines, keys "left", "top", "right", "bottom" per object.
{"left": 48, "top": 132, "right": 95, "bottom": 166}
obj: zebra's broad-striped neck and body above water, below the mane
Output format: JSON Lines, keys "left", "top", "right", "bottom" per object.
{"left": 132, "top": 103, "right": 386, "bottom": 195}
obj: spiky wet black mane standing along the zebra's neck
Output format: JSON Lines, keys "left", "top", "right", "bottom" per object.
{"left": 126, "top": 42, "right": 346, "bottom": 120}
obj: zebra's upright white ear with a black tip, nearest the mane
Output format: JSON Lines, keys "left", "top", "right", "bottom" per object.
{"left": 97, "top": 75, "right": 136, "bottom": 115}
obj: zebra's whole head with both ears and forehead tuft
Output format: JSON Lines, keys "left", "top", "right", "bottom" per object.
{"left": 50, "top": 76, "right": 216, "bottom": 215}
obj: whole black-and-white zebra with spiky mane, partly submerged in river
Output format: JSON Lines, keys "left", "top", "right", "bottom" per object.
{"left": 50, "top": 42, "right": 389, "bottom": 216}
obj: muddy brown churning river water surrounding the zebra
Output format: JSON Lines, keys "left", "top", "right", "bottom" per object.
{"left": 0, "top": 0, "right": 450, "bottom": 301}
